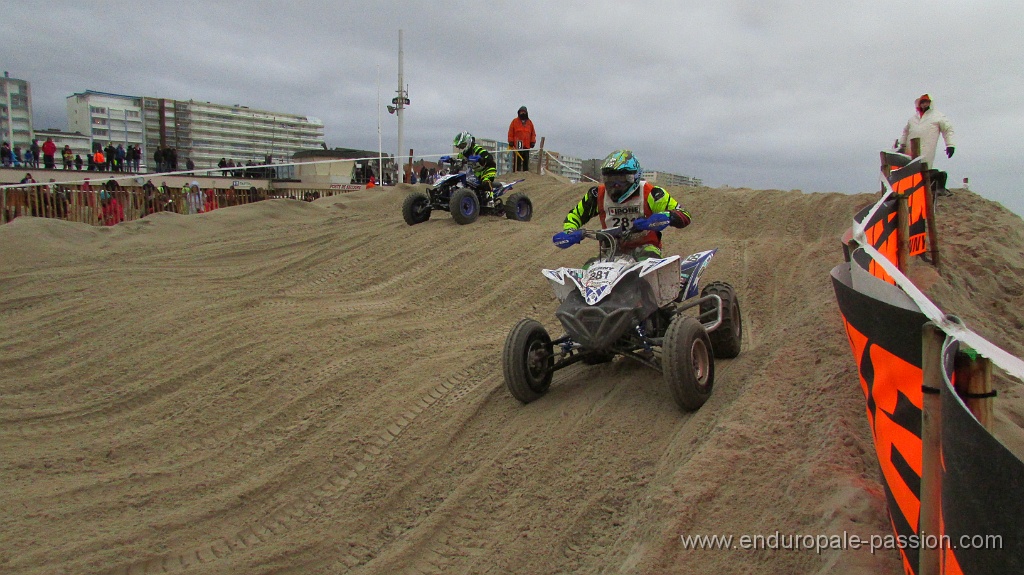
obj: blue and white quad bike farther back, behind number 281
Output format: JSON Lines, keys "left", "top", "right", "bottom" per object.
{"left": 401, "top": 156, "right": 534, "bottom": 225}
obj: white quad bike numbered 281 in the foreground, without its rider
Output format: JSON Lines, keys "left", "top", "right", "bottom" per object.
{"left": 502, "top": 222, "right": 742, "bottom": 411}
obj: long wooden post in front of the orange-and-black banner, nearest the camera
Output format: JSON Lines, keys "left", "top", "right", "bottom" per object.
{"left": 918, "top": 321, "right": 946, "bottom": 575}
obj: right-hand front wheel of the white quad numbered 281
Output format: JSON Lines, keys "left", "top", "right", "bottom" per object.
{"left": 662, "top": 315, "right": 715, "bottom": 411}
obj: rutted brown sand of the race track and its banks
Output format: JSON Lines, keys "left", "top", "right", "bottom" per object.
{"left": 0, "top": 175, "right": 1024, "bottom": 575}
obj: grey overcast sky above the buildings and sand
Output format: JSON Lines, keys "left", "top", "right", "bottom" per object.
{"left": 0, "top": 0, "right": 1024, "bottom": 214}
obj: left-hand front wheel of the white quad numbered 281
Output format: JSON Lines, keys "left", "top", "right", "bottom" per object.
{"left": 502, "top": 319, "right": 554, "bottom": 403}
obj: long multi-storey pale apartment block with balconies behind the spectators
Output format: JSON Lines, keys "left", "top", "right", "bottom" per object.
{"left": 68, "top": 90, "right": 325, "bottom": 172}
